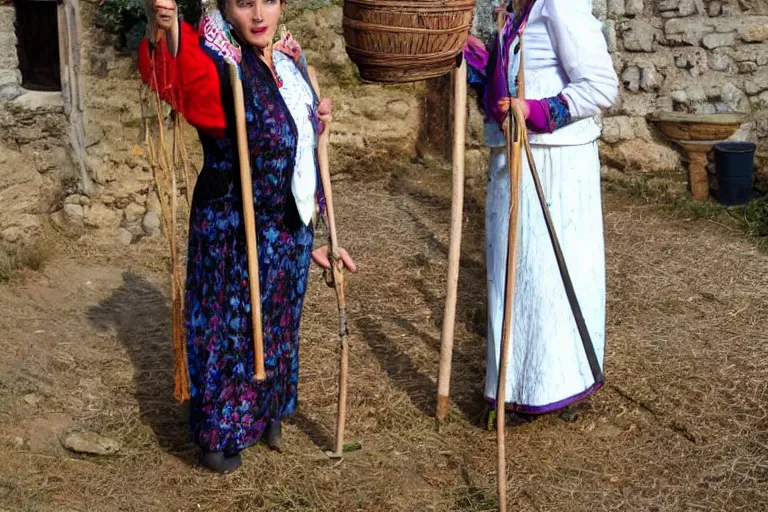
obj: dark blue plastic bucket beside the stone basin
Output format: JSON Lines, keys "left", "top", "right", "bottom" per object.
{"left": 714, "top": 142, "right": 757, "bottom": 206}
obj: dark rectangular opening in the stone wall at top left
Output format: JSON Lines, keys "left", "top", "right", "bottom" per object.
{"left": 14, "top": 0, "right": 61, "bottom": 91}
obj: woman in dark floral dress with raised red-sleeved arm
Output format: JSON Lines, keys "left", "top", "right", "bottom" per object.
{"left": 139, "top": 0, "right": 354, "bottom": 472}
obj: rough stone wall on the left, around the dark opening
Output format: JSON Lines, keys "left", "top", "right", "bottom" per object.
{"left": 0, "top": 0, "right": 159, "bottom": 243}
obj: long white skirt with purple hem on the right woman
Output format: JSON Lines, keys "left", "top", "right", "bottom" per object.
{"left": 485, "top": 142, "right": 605, "bottom": 414}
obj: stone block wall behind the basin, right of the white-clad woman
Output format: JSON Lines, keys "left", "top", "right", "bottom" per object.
{"left": 593, "top": 0, "right": 768, "bottom": 178}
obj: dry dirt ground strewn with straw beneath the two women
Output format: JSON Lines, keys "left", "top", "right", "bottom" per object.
{"left": 0, "top": 5, "right": 768, "bottom": 511}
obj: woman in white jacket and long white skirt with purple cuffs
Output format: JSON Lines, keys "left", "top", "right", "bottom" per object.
{"left": 465, "top": 0, "right": 618, "bottom": 422}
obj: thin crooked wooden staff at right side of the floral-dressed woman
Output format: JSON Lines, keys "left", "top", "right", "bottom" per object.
{"left": 309, "top": 70, "right": 349, "bottom": 458}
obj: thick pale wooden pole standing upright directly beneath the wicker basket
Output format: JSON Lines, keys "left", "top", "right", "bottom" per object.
{"left": 436, "top": 59, "right": 467, "bottom": 422}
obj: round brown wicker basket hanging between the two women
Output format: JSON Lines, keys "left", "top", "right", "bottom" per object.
{"left": 344, "top": 0, "right": 475, "bottom": 83}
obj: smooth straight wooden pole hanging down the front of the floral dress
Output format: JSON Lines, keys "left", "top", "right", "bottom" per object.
{"left": 229, "top": 64, "right": 267, "bottom": 381}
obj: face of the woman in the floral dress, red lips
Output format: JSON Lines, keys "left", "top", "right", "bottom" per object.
{"left": 226, "top": 0, "right": 283, "bottom": 49}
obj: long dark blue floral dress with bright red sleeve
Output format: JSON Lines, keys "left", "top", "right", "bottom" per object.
{"left": 140, "top": 25, "right": 319, "bottom": 452}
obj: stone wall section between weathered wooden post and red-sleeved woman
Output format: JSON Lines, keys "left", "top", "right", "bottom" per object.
{"left": 66, "top": 2, "right": 163, "bottom": 244}
